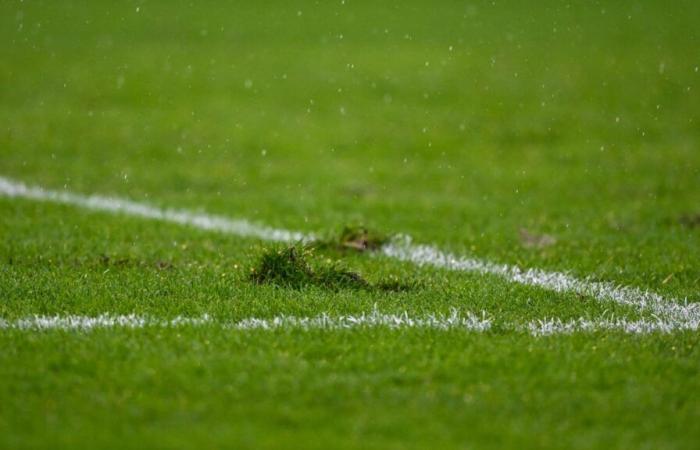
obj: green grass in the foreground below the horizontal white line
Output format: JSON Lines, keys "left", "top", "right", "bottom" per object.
{"left": 0, "top": 329, "right": 700, "bottom": 448}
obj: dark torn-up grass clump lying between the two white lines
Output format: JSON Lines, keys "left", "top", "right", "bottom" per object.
{"left": 250, "top": 246, "right": 413, "bottom": 292}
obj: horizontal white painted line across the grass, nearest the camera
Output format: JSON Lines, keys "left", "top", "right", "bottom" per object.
{"left": 0, "top": 310, "right": 700, "bottom": 336}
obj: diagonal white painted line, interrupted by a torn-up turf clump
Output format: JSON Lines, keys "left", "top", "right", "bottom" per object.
{"left": 0, "top": 177, "right": 700, "bottom": 328}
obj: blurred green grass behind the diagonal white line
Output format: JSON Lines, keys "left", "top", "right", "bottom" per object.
{"left": 0, "top": 0, "right": 700, "bottom": 299}
